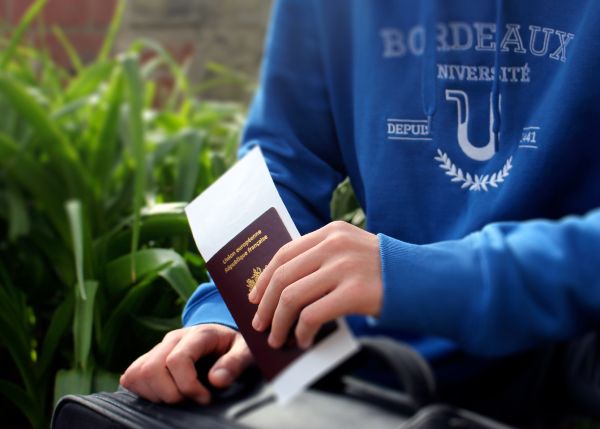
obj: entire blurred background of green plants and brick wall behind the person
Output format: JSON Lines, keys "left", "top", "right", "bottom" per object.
{"left": 0, "top": 0, "right": 364, "bottom": 428}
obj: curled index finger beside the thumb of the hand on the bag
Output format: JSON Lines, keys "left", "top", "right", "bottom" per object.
{"left": 166, "top": 328, "right": 235, "bottom": 405}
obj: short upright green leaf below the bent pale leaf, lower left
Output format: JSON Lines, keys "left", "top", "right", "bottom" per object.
{"left": 73, "top": 281, "right": 98, "bottom": 371}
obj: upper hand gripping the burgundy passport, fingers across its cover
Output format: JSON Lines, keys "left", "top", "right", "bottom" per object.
{"left": 248, "top": 222, "right": 383, "bottom": 348}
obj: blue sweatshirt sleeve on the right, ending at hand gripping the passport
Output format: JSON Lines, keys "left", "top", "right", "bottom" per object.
{"left": 375, "top": 209, "right": 600, "bottom": 356}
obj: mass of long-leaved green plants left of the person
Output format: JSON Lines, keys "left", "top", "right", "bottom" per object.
{"left": 0, "top": 0, "right": 243, "bottom": 427}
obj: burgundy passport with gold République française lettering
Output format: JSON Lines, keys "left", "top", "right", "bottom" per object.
{"left": 206, "top": 207, "right": 337, "bottom": 381}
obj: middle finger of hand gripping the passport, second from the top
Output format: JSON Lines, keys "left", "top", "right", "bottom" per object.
{"left": 252, "top": 245, "right": 323, "bottom": 331}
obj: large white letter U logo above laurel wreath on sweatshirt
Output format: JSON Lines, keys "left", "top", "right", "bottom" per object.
{"left": 446, "top": 89, "right": 500, "bottom": 161}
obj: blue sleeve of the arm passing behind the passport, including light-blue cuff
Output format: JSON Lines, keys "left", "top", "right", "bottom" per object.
{"left": 183, "top": 0, "right": 346, "bottom": 326}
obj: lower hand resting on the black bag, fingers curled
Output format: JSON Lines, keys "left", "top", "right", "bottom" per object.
{"left": 121, "top": 324, "right": 252, "bottom": 405}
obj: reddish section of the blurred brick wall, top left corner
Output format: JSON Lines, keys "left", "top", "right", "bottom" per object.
{"left": 0, "top": 0, "right": 117, "bottom": 67}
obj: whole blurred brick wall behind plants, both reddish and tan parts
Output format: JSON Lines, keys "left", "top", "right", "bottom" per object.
{"left": 0, "top": 0, "right": 271, "bottom": 99}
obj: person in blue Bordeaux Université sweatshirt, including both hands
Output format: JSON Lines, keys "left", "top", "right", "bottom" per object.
{"left": 121, "top": 0, "right": 600, "bottom": 424}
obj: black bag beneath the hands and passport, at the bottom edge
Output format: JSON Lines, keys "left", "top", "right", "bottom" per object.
{"left": 52, "top": 338, "right": 508, "bottom": 429}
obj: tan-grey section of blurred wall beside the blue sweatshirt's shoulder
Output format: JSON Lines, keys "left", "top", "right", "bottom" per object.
{"left": 118, "top": 0, "right": 271, "bottom": 100}
